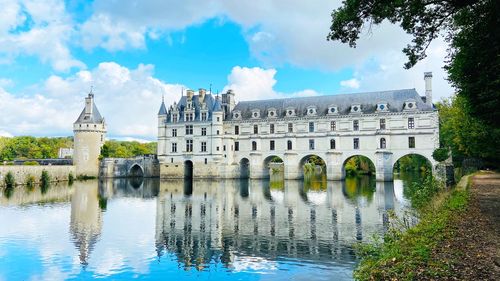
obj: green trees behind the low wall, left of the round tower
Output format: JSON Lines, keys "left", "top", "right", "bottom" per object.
{"left": 0, "top": 136, "right": 73, "bottom": 161}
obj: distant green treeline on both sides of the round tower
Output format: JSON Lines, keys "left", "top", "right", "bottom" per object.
{"left": 0, "top": 136, "right": 156, "bottom": 162}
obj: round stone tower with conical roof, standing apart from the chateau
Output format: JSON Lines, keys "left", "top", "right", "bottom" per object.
{"left": 73, "top": 91, "right": 106, "bottom": 177}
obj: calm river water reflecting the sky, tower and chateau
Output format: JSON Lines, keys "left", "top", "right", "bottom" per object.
{"left": 0, "top": 174, "right": 409, "bottom": 280}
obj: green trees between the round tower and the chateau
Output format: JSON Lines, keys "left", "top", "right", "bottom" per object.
{"left": 101, "top": 140, "right": 156, "bottom": 158}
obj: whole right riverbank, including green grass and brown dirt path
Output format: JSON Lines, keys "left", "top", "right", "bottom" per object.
{"left": 355, "top": 173, "right": 500, "bottom": 280}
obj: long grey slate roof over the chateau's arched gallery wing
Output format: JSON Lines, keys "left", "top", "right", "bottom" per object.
{"left": 229, "top": 89, "right": 434, "bottom": 119}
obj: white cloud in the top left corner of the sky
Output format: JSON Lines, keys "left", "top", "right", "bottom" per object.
{"left": 0, "top": 0, "right": 85, "bottom": 71}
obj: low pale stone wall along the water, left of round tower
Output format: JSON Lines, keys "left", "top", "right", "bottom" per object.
{"left": 0, "top": 165, "right": 76, "bottom": 186}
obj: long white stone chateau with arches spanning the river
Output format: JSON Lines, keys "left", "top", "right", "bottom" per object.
{"left": 158, "top": 72, "right": 439, "bottom": 180}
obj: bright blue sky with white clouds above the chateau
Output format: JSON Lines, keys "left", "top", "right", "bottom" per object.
{"left": 0, "top": 0, "right": 453, "bottom": 140}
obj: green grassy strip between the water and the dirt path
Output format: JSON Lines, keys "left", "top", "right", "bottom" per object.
{"left": 354, "top": 174, "right": 469, "bottom": 280}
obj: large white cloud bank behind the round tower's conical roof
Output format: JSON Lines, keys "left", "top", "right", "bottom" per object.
{"left": 0, "top": 62, "right": 183, "bottom": 139}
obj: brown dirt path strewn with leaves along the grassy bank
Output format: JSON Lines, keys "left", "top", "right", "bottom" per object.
{"left": 435, "top": 173, "right": 500, "bottom": 280}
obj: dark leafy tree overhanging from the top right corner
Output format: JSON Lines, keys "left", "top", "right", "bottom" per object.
{"left": 327, "top": 0, "right": 500, "bottom": 165}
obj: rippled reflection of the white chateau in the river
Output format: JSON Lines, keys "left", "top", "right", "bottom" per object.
{"left": 156, "top": 176, "right": 397, "bottom": 269}
